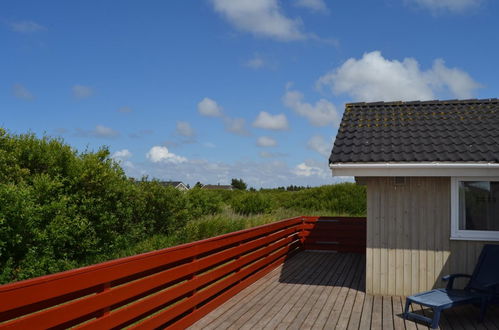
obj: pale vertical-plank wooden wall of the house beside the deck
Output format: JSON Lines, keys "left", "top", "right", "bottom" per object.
{"left": 366, "top": 177, "right": 498, "bottom": 295}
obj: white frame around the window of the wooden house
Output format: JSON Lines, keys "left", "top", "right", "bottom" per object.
{"left": 450, "top": 176, "right": 499, "bottom": 241}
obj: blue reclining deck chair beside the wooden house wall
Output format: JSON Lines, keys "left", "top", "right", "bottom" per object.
{"left": 403, "top": 244, "right": 499, "bottom": 328}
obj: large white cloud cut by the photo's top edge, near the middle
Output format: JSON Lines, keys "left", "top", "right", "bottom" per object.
{"left": 211, "top": 0, "right": 307, "bottom": 41}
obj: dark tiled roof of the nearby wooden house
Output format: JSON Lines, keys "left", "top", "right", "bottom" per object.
{"left": 329, "top": 99, "right": 499, "bottom": 163}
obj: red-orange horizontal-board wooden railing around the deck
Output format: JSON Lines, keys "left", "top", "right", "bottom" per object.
{"left": 0, "top": 217, "right": 365, "bottom": 329}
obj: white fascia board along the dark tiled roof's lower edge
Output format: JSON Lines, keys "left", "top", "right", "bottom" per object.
{"left": 329, "top": 162, "right": 499, "bottom": 176}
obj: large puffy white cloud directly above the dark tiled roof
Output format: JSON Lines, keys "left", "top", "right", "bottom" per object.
{"left": 317, "top": 51, "right": 480, "bottom": 101}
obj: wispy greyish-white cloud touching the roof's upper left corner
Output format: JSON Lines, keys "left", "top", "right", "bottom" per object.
{"left": 282, "top": 90, "right": 339, "bottom": 126}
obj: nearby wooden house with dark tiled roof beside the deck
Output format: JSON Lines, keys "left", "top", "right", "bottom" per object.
{"left": 329, "top": 99, "right": 499, "bottom": 295}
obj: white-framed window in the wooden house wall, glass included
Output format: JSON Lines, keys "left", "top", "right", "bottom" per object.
{"left": 451, "top": 177, "right": 499, "bottom": 241}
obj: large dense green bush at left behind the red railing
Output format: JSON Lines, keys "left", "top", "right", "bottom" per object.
{"left": 0, "top": 130, "right": 192, "bottom": 283}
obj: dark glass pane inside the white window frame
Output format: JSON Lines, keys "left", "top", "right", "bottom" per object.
{"left": 459, "top": 181, "right": 499, "bottom": 231}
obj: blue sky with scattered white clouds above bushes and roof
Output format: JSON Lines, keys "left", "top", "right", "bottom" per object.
{"left": 0, "top": 0, "right": 499, "bottom": 188}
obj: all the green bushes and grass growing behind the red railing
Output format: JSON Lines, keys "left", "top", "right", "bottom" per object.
{"left": 0, "top": 129, "right": 366, "bottom": 283}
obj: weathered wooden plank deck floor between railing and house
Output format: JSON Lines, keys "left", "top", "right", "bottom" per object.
{"left": 190, "top": 251, "right": 499, "bottom": 329}
